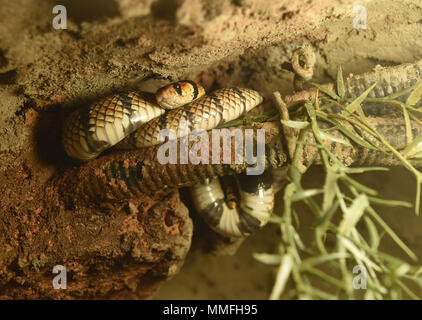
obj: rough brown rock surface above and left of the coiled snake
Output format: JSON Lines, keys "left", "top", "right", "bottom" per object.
{"left": 0, "top": 0, "right": 422, "bottom": 299}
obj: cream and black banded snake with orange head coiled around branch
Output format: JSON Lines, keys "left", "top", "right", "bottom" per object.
{"left": 62, "top": 80, "right": 274, "bottom": 237}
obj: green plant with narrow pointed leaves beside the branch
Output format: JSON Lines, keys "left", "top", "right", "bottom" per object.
{"left": 254, "top": 69, "right": 422, "bottom": 299}
